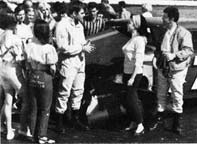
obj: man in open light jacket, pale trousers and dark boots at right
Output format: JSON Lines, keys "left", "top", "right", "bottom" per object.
{"left": 153, "top": 7, "right": 193, "bottom": 134}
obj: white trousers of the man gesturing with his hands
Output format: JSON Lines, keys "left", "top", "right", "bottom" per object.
{"left": 56, "top": 65, "right": 85, "bottom": 114}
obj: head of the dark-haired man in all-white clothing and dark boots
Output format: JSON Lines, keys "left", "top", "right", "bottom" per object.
{"left": 68, "top": 2, "right": 85, "bottom": 21}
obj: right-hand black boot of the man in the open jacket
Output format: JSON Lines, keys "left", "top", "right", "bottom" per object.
{"left": 172, "top": 113, "right": 183, "bottom": 136}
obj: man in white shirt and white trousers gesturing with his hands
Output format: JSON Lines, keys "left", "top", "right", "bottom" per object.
{"left": 56, "top": 3, "right": 94, "bottom": 132}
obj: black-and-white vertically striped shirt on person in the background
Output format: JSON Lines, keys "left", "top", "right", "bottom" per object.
{"left": 83, "top": 16, "right": 105, "bottom": 36}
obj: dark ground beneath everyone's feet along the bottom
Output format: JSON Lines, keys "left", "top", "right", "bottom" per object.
{"left": 1, "top": 99, "right": 197, "bottom": 144}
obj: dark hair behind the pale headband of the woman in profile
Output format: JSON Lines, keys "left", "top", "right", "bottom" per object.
{"left": 137, "top": 15, "right": 149, "bottom": 37}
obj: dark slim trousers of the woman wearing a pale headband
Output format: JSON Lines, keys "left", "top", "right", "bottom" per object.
{"left": 123, "top": 74, "right": 143, "bottom": 124}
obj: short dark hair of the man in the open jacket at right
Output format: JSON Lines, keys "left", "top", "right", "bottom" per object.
{"left": 163, "top": 6, "right": 179, "bottom": 22}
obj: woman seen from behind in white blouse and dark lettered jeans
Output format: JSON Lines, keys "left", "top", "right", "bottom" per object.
{"left": 25, "top": 20, "right": 58, "bottom": 144}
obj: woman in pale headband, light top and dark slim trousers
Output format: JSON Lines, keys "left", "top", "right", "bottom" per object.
{"left": 122, "top": 15, "right": 148, "bottom": 135}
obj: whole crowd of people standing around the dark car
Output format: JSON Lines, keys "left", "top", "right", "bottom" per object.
{"left": 0, "top": 0, "right": 193, "bottom": 144}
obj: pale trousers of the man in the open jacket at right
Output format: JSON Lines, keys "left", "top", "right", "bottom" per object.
{"left": 157, "top": 68, "right": 188, "bottom": 113}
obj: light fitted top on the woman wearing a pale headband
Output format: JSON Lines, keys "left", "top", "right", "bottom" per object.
{"left": 122, "top": 36, "right": 147, "bottom": 74}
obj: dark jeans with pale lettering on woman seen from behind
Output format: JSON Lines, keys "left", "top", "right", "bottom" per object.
{"left": 28, "top": 71, "right": 53, "bottom": 138}
